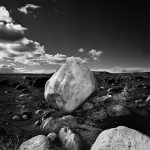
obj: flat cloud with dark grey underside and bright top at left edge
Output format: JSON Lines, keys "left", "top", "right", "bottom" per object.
{"left": 0, "top": 22, "right": 27, "bottom": 42}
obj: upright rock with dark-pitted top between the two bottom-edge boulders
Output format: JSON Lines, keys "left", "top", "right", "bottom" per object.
{"left": 59, "top": 127, "right": 82, "bottom": 150}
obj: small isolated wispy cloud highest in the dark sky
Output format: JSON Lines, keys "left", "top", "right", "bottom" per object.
{"left": 18, "top": 4, "right": 41, "bottom": 15}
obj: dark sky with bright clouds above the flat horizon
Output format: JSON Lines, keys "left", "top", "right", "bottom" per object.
{"left": 0, "top": 0, "right": 150, "bottom": 73}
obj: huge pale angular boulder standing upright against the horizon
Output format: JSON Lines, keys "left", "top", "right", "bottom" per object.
{"left": 44, "top": 58, "right": 96, "bottom": 113}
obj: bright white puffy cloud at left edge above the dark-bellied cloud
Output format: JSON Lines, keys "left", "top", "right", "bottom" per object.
{"left": 0, "top": 6, "right": 13, "bottom": 23}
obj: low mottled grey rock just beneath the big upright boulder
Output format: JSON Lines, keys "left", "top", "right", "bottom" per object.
{"left": 41, "top": 115, "right": 77, "bottom": 133}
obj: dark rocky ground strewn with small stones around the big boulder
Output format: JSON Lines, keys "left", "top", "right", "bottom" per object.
{"left": 0, "top": 72, "right": 150, "bottom": 150}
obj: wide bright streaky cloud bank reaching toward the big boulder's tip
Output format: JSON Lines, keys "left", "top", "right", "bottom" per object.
{"left": 0, "top": 38, "right": 67, "bottom": 66}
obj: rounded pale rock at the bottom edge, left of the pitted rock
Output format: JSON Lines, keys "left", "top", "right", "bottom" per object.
{"left": 19, "top": 135, "right": 50, "bottom": 150}
